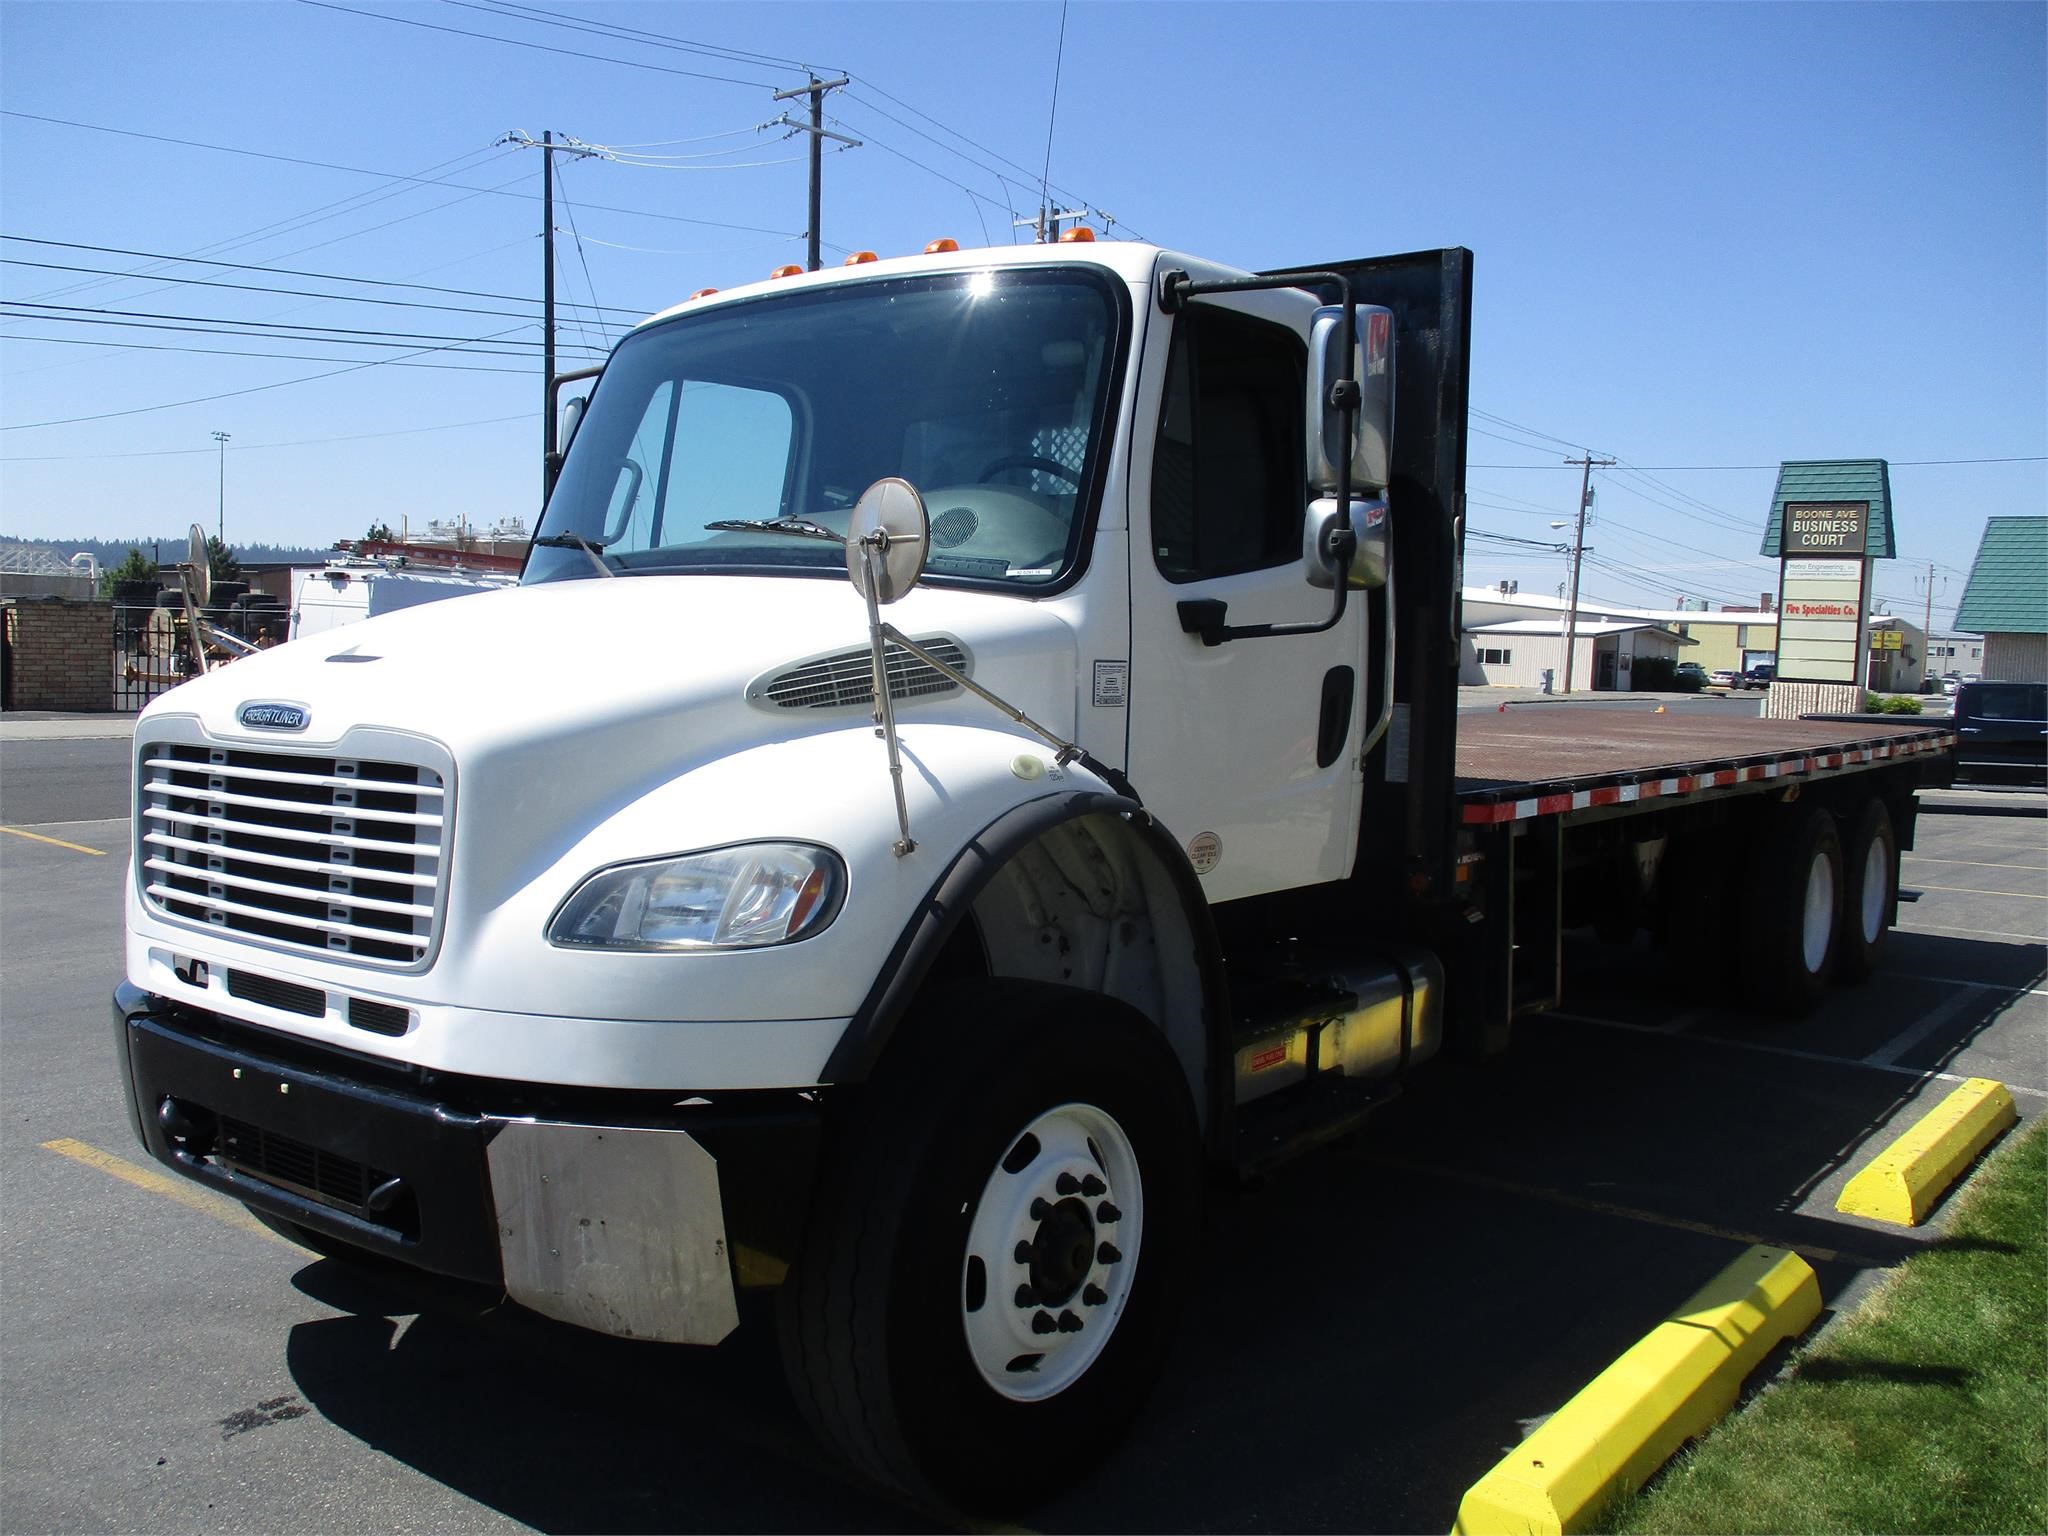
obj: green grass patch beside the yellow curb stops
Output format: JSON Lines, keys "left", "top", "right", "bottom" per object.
{"left": 1608, "top": 1122, "right": 2048, "bottom": 1532}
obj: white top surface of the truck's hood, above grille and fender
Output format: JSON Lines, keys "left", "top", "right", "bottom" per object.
{"left": 149, "top": 575, "right": 1077, "bottom": 877}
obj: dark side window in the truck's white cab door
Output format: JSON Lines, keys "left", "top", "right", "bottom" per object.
{"left": 1151, "top": 305, "right": 1309, "bottom": 582}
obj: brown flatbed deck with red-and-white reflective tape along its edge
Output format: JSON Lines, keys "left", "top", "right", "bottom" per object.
{"left": 1458, "top": 705, "right": 1956, "bottom": 825}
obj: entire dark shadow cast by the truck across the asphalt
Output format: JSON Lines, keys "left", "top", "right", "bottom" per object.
{"left": 289, "top": 934, "right": 2042, "bottom": 1532}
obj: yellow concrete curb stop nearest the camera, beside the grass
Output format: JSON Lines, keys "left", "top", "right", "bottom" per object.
{"left": 1454, "top": 1245, "right": 1821, "bottom": 1536}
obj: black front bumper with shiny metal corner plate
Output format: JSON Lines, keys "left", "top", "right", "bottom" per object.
{"left": 113, "top": 983, "right": 821, "bottom": 1343}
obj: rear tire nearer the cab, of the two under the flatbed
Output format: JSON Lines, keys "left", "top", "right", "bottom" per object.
{"left": 1741, "top": 805, "right": 1845, "bottom": 1018}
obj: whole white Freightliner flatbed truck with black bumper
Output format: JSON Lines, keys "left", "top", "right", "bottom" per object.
{"left": 115, "top": 244, "right": 1952, "bottom": 1509}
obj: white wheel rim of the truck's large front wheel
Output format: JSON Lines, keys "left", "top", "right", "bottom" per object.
{"left": 961, "top": 1104, "right": 1145, "bottom": 1403}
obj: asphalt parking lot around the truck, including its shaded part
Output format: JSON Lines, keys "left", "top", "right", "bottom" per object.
{"left": 0, "top": 739, "right": 2048, "bottom": 1532}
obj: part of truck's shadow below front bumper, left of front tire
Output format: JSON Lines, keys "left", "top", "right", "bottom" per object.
{"left": 285, "top": 1260, "right": 932, "bottom": 1532}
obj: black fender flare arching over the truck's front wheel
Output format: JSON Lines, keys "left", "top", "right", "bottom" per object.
{"left": 819, "top": 791, "right": 1233, "bottom": 1145}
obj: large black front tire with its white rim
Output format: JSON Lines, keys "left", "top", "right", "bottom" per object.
{"left": 778, "top": 981, "right": 1204, "bottom": 1513}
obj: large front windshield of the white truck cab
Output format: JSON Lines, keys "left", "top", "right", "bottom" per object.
{"left": 524, "top": 268, "right": 1120, "bottom": 590}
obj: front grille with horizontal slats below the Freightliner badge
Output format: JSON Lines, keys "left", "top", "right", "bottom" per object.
{"left": 135, "top": 741, "right": 446, "bottom": 967}
